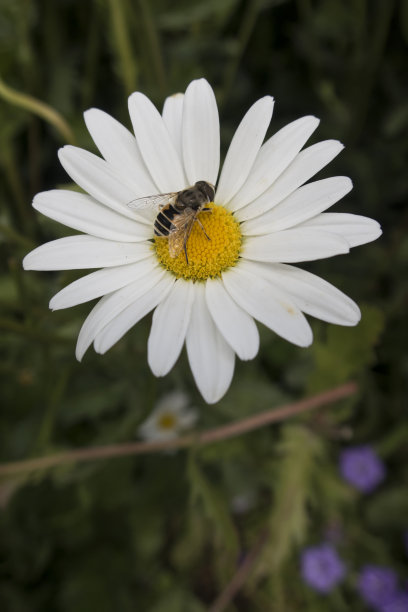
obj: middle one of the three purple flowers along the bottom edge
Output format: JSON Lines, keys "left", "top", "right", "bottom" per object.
{"left": 357, "top": 565, "right": 398, "bottom": 612}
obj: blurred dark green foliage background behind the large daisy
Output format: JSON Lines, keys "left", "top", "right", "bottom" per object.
{"left": 0, "top": 0, "right": 408, "bottom": 612}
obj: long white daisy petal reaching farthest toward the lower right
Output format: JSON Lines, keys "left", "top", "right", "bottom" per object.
{"left": 246, "top": 262, "right": 361, "bottom": 325}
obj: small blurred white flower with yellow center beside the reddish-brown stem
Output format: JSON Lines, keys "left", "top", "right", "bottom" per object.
{"left": 139, "top": 391, "right": 198, "bottom": 441}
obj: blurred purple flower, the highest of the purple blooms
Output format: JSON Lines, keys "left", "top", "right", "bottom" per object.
{"left": 340, "top": 446, "right": 385, "bottom": 493}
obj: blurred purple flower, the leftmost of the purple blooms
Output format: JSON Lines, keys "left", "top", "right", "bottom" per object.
{"left": 301, "top": 544, "right": 346, "bottom": 593}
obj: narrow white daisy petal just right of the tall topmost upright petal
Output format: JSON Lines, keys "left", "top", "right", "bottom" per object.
{"left": 215, "top": 96, "right": 273, "bottom": 204}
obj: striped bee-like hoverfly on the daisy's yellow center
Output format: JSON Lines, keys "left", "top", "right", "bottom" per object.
{"left": 128, "top": 181, "right": 215, "bottom": 265}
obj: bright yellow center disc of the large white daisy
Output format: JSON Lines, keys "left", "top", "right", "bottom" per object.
{"left": 154, "top": 202, "right": 242, "bottom": 280}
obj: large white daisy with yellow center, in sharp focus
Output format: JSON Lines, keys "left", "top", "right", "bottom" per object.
{"left": 24, "top": 79, "right": 381, "bottom": 403}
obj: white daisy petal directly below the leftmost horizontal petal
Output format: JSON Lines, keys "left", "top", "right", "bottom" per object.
{"left": 50, "top": 254, "right": 154, "bottom": 310}
